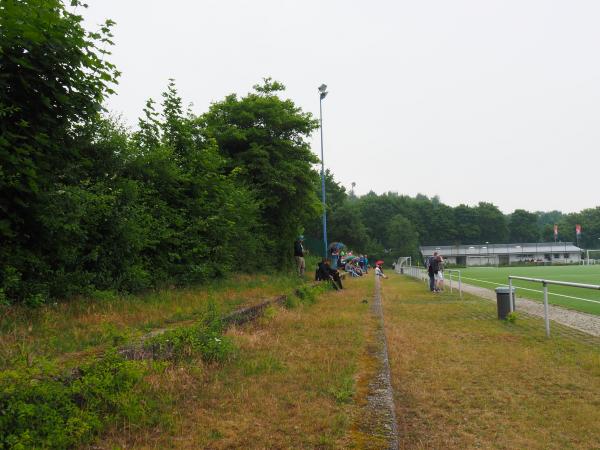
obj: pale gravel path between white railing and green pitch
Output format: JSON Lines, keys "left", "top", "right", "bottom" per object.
{"left": 462, "top": 283, "right": 600, "bottom": 336}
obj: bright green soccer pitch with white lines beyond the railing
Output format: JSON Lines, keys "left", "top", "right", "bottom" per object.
{"left": 460, "top": 265, "right": 600, "bottom": 315}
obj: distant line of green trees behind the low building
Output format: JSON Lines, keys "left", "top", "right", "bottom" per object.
{"left": 307, "top": 173, "right": 600, "bottom": 259}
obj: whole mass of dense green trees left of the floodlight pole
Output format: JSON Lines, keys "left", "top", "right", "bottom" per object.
{"left": 0, "top": 0, "right": 320, "bottom": 305}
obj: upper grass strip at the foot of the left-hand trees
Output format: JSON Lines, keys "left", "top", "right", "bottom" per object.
{"left": 0, "top": 275, "right": 299, "bottom": 370}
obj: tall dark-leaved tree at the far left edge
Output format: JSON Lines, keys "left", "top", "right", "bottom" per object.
{"left": 0, "top": 0, "right": 119, "bottom": 299}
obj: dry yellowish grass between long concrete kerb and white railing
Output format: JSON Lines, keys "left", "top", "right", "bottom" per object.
{"left": 383, "top": 277, "right": 600, "bottom": 449}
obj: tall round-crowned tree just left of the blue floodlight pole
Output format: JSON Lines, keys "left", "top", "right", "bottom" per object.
{"left": 201, "top": 78, "right": 320, "bottom": 264}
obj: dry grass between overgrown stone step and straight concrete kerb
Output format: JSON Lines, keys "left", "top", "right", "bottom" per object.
{"left": 95, "top": 278, "right": 373, "bottom": 449}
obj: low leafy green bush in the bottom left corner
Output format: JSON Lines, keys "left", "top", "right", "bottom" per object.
{"left": 0, "top": 353, "right": 145, "bottom": 449}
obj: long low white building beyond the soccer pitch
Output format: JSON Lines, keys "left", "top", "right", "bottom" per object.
{"left": 421, "top": 242, "right": 582, "bottom": 266}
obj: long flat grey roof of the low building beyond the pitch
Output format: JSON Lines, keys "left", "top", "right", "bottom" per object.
{"left": 421, "top": 242, "right": 581, "bottom": 256}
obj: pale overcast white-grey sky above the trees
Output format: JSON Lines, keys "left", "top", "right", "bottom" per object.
{"left": 78, "top": 0, "right": 600, "bottom": 213}
